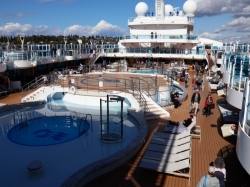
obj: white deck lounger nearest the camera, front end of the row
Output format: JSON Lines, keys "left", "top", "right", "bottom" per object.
{"left": 139, "top": 158, "right": 190, "bottom": 179}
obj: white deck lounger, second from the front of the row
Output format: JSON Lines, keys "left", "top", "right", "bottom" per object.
{"left": 143, "top": 150, "right": 190, "bottom": 163}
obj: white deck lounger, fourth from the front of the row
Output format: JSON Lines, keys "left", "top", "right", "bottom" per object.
{"left": 150, "top": 136, "right": 191, "bottom": 146}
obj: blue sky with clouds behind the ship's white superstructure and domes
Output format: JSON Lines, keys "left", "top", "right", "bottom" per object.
{"left": 0, "top": 0, "right": 250, "bottom": 43}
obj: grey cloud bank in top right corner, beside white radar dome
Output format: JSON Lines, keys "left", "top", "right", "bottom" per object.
{"left": 194, "top": 0, "right": 250, "bottom": 18}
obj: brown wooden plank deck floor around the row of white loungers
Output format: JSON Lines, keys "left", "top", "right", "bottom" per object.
{"left": 0, "top": 72, "right": 250, "bottom": 187}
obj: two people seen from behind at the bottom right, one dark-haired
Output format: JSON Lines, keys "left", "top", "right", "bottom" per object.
{"left": 196, "top": 156, "right": 226, "bottom": 187}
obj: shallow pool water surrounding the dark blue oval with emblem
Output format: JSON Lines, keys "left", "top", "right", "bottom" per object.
{"left": 0, "top": 95, "right": 143, "bottom": 187}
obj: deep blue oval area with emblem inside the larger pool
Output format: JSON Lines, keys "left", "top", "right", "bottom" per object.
{"left": 8, "top": 116, "right": 90, "bottom": 146}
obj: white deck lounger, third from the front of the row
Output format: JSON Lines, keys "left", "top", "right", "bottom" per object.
{"left": 147, "top": 142, "right": 190, "bottom": 154}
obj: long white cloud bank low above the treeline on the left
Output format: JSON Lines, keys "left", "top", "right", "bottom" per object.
{"left": 0, "top": 20, "right": 128, "bottom": 36}
